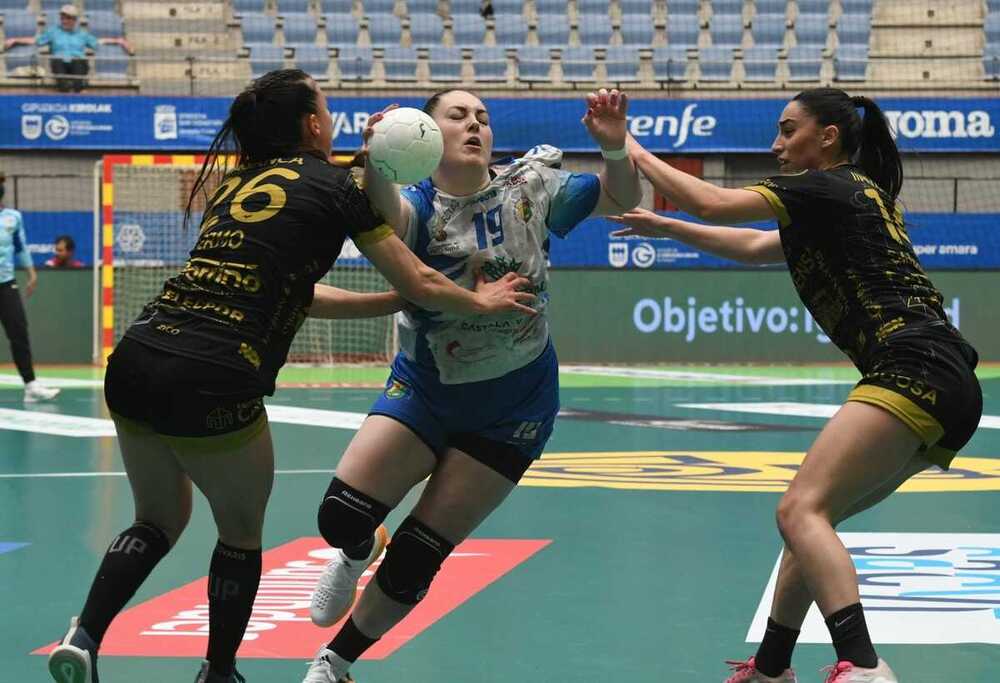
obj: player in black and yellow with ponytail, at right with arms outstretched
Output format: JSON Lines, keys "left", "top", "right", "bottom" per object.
{"left": 616, "top": 88, "right": 982, "bottom": 683}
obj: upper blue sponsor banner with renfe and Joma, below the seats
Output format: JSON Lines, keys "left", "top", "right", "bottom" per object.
{"left": 0, "top": 94, "right": 1000, "bottom": 154}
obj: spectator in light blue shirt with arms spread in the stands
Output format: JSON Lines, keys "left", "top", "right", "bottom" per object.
{"left": 4, "top": 4, "right": 132, "bottom": 92}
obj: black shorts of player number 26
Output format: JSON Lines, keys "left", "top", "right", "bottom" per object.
{"left": 104, "top": 337, "right": 267, "bottom": 450}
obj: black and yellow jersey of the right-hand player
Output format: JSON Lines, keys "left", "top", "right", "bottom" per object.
{"left": 747, "top": 165, "right": 962, "bottom": 373}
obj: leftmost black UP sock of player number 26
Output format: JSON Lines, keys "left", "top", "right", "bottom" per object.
{"left": 80, "top": 522, "right": 170, "bottom": 645}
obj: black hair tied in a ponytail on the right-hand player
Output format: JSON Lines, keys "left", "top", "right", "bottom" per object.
{"left": 794, "top": 88, "right": 903, "bottom": 201}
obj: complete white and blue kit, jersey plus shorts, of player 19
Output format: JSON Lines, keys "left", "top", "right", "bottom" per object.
{"left": 370, "top": 146, "right": 601, "bottom": 464}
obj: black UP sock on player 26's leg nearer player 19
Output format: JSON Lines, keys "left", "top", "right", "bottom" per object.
{"left": 205, "top": 541, "right": 261, "bottom": 676}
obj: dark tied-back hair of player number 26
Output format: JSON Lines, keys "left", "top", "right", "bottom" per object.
{"left": 184, "top": 69, "right": 319, "bottom": 229}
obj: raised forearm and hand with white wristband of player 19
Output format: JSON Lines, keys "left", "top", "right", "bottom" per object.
{"left": 583, "top": 88, "right": 642, "bottom": 216}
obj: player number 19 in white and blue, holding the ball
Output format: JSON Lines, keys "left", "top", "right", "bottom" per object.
{"left": 305, "top": 90, "right": 642, "bottom": 683}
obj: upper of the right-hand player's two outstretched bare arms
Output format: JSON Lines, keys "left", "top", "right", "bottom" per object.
{"left": 628, "top": 135, "right": 776, "bottom": 223}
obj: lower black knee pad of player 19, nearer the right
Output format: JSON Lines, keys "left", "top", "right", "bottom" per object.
{"left": 375, "top": 516, "right": 455, "bottom": 605}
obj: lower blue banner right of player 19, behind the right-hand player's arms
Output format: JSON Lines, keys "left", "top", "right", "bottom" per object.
{"left": 550, "top": 213, "right": 1000, "bottom": 270}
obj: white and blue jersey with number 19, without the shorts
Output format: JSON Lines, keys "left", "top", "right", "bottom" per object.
{"left": 398, "top": 145, "right": 601, "bottom": 384}
